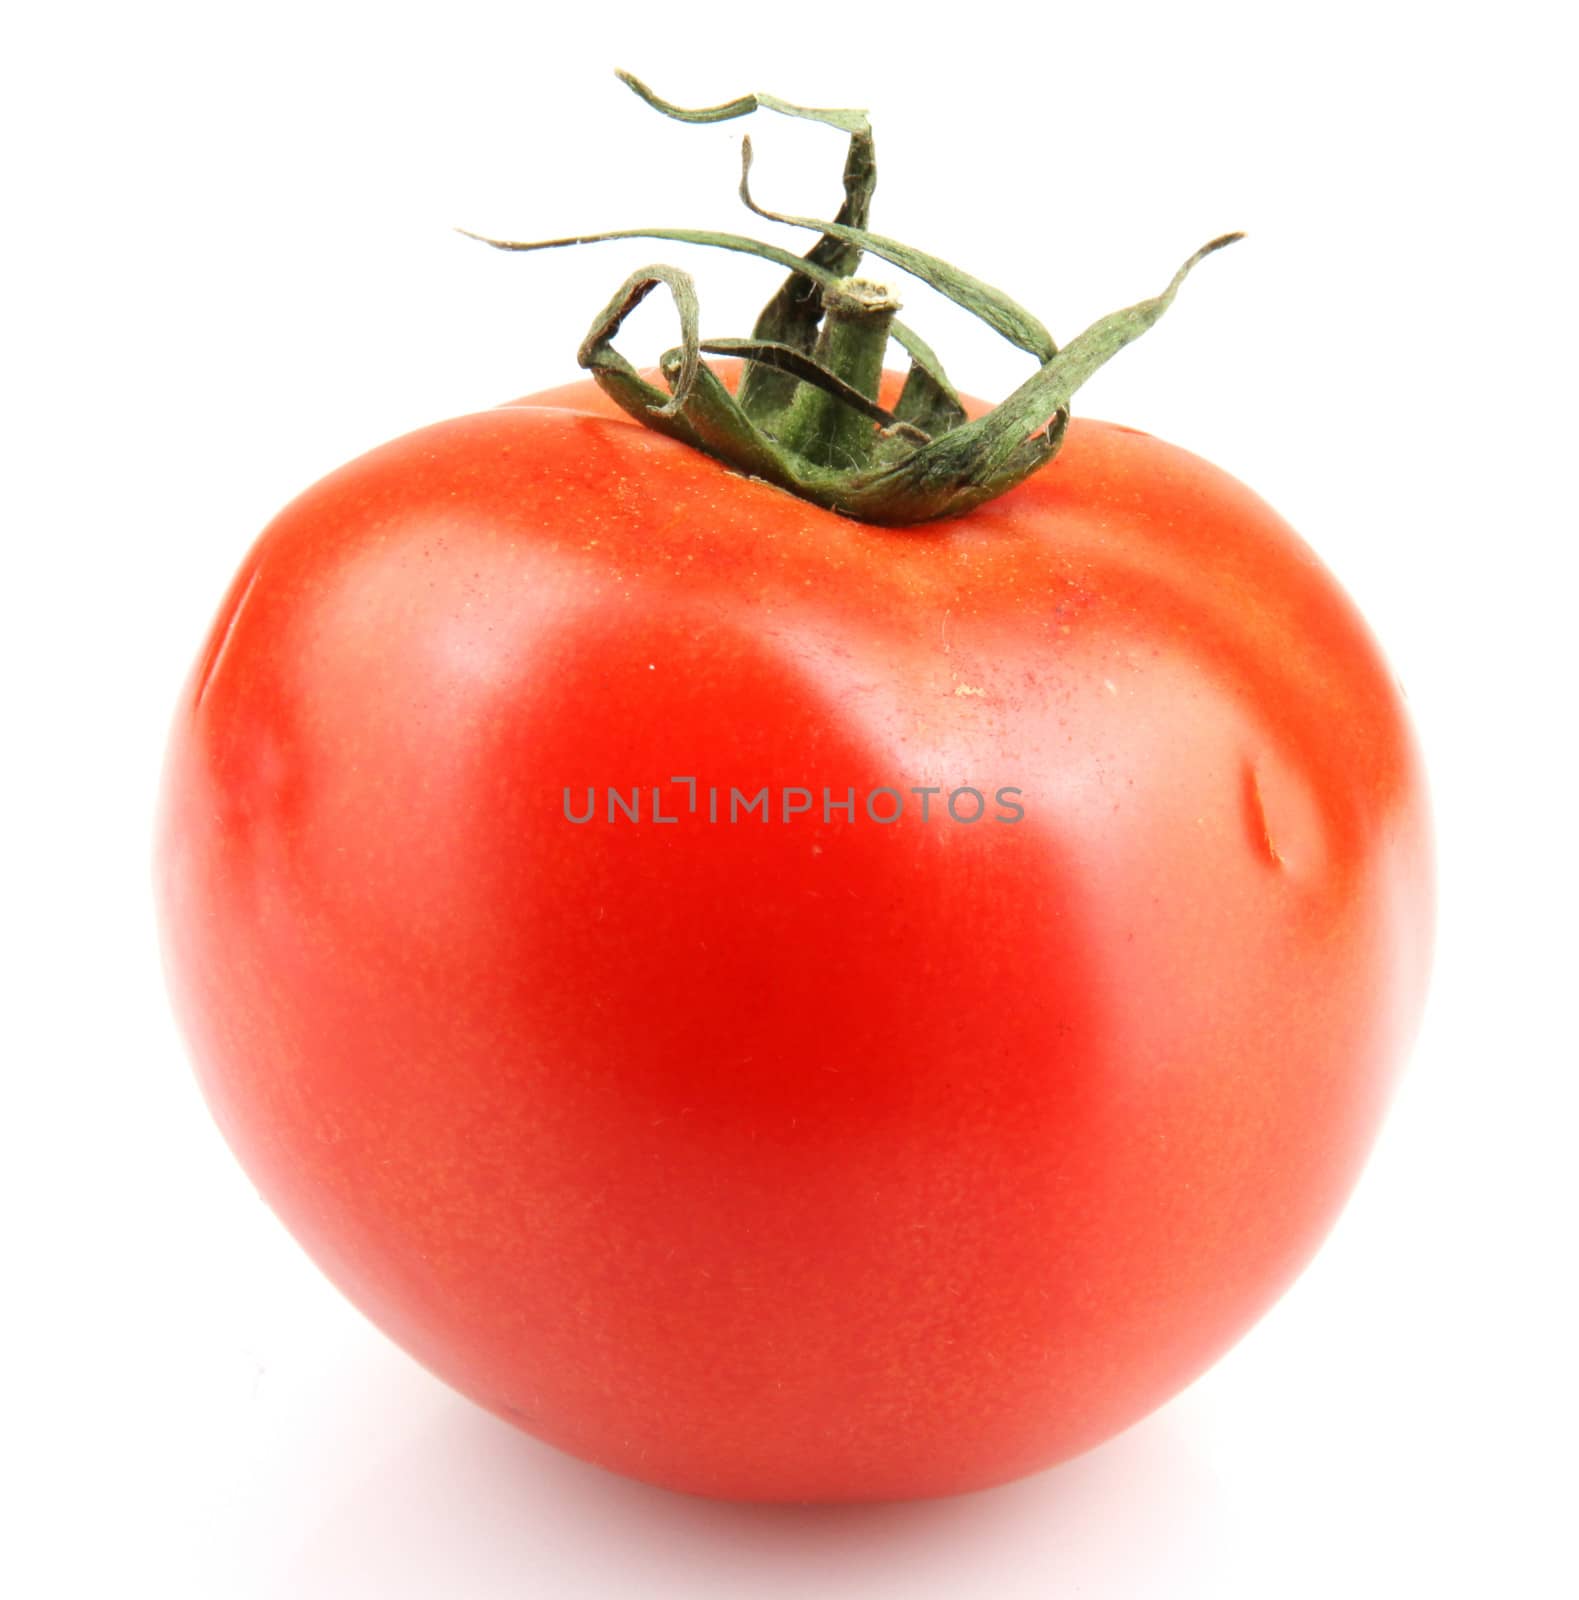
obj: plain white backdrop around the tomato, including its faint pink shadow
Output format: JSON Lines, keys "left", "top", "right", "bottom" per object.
{"left": 0, "top": 0, "right": 1579, "bottom": 1600}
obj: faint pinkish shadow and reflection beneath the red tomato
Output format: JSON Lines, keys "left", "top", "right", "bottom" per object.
{"left": 282, "top": 1376, "right": 1222, "bottom": 1600}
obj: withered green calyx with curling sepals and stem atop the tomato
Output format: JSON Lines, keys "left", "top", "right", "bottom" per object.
{"left": 462, "top": 72, "right": 1243, "bottom": 526}
